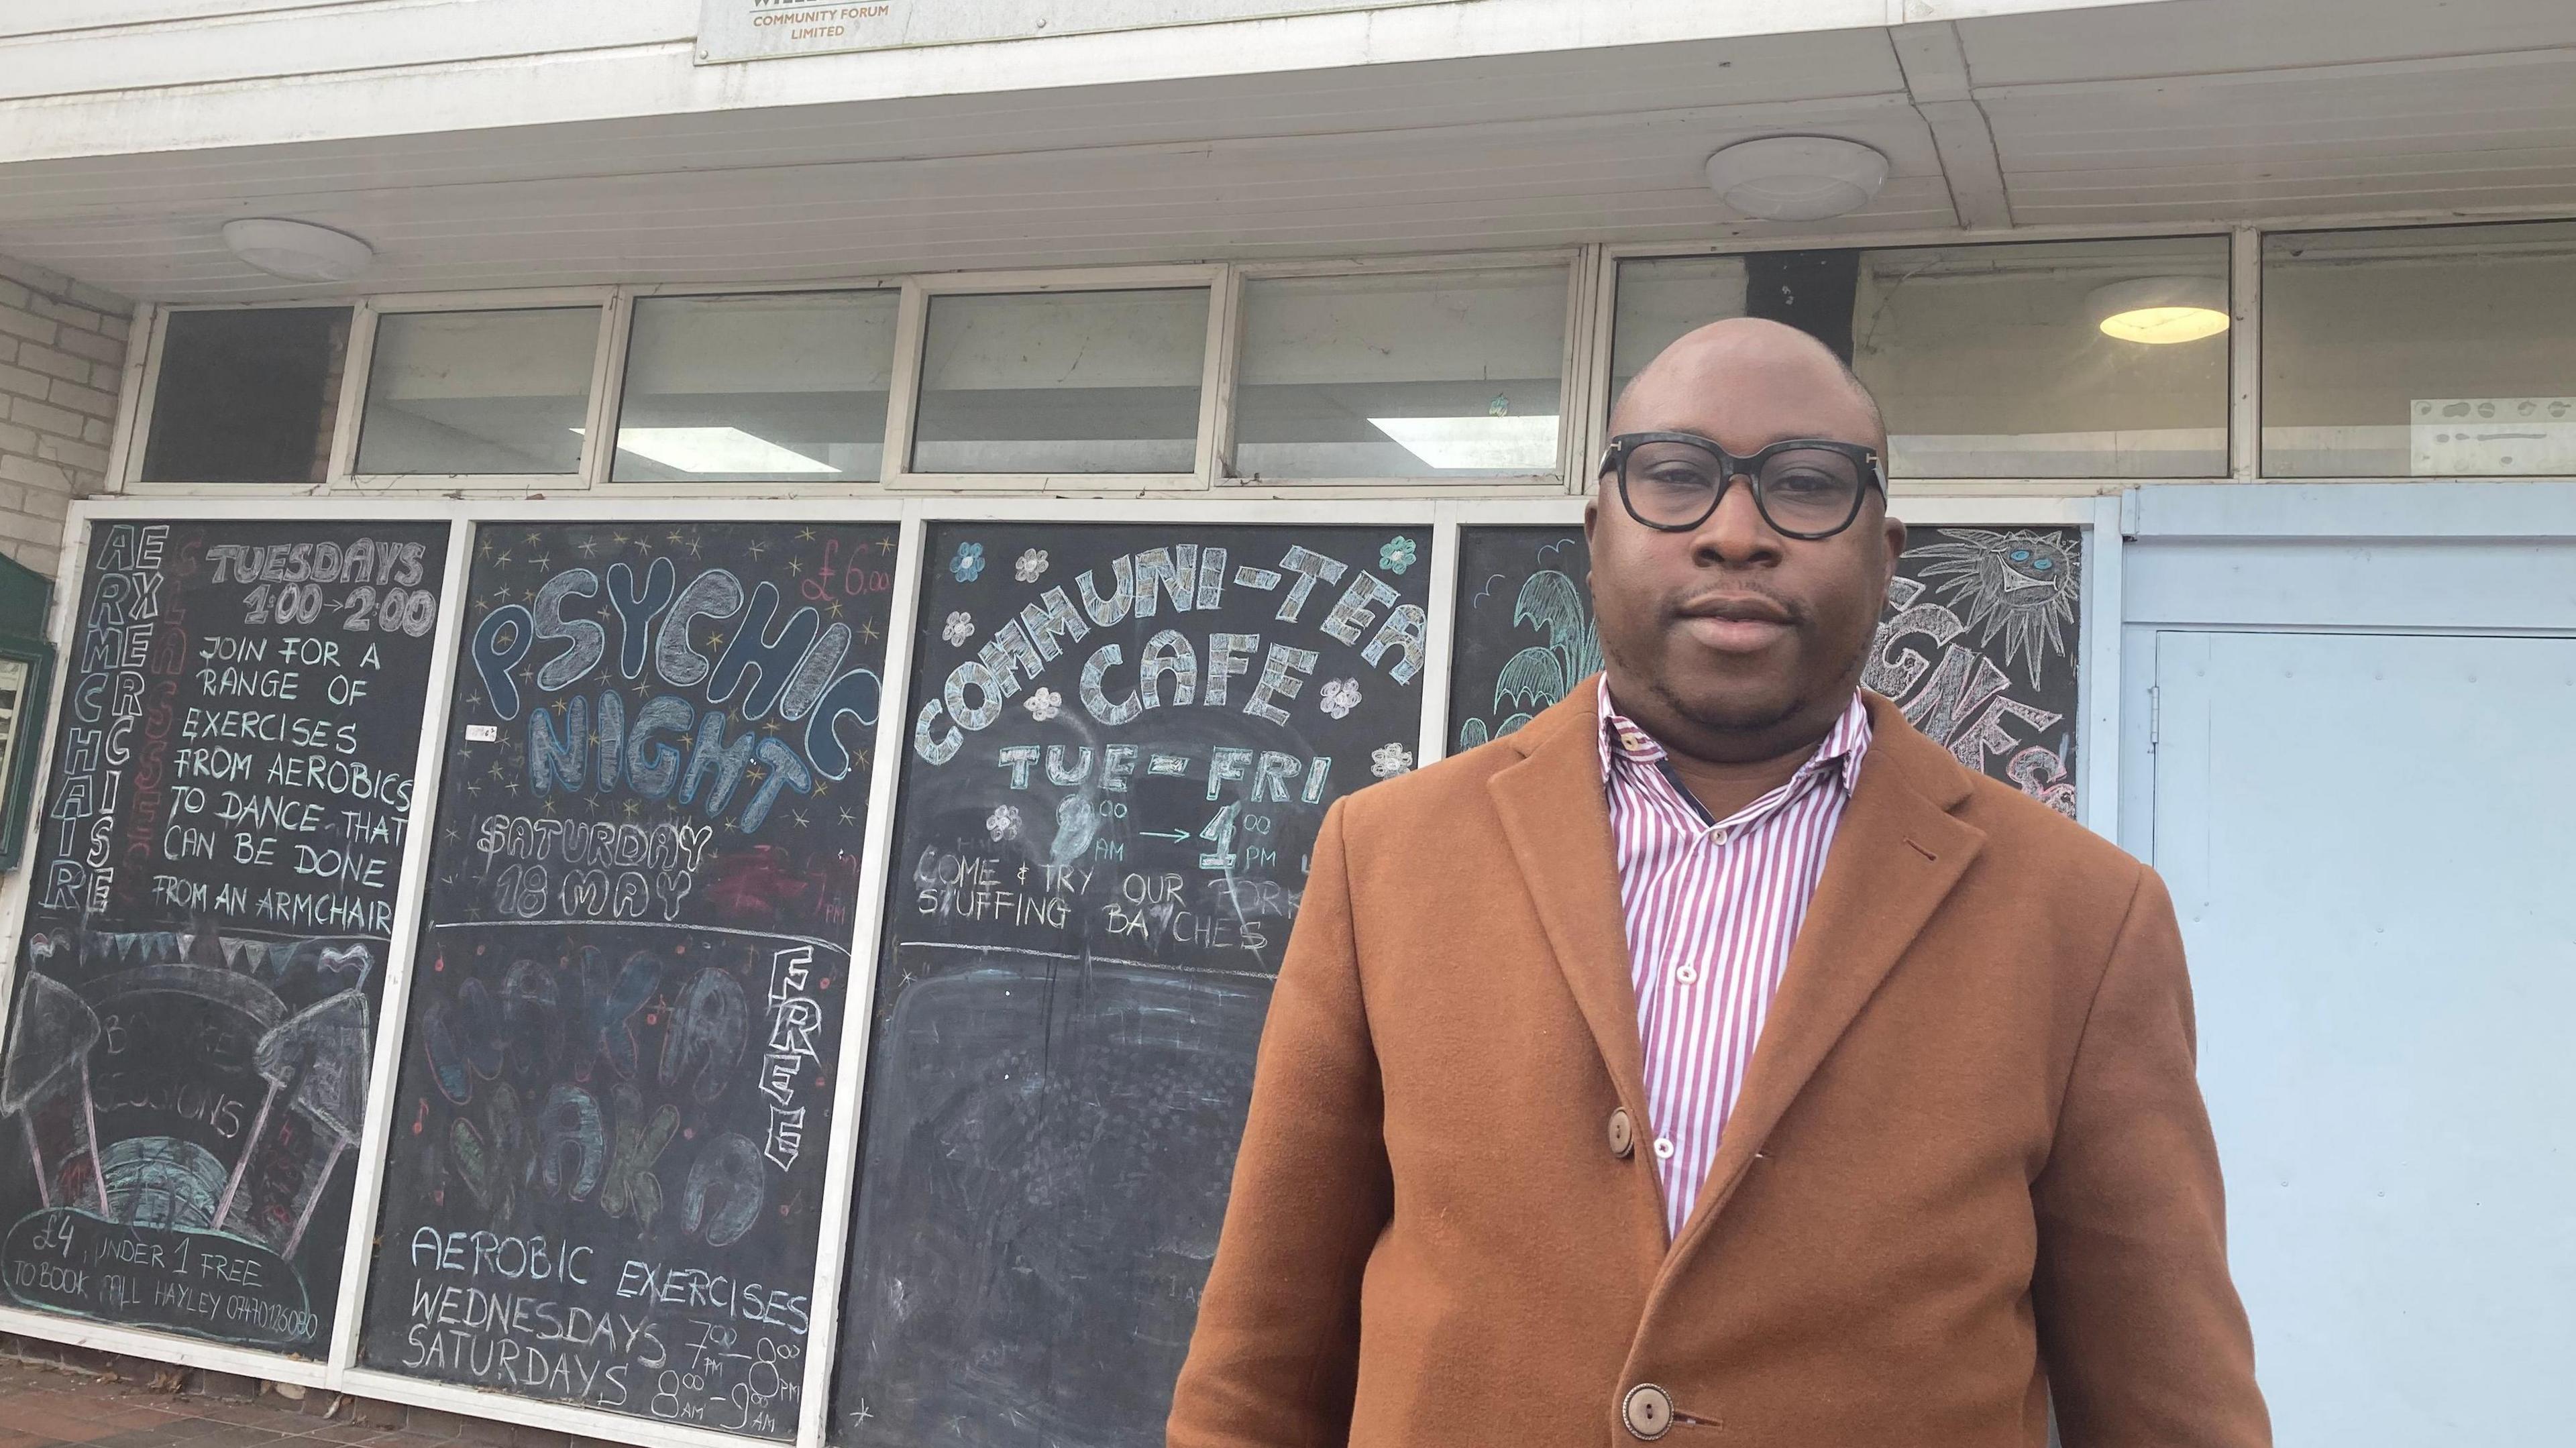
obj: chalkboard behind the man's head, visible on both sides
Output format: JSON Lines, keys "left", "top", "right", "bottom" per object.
{"left": 1448, "top": 526, "right": 2084, "bottom": 817}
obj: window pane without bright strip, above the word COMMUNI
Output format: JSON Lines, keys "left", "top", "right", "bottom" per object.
{"left": 912, "top": 286, "right": 1208, "bottom": 471}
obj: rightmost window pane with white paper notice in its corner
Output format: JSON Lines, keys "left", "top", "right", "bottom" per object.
{"left": 2262, "top": 224, "right": 2576, "bottom": 477}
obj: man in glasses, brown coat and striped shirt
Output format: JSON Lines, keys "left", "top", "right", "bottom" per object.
{"left": 1169, "top": 319, "right": 2269, "bottom": 1448}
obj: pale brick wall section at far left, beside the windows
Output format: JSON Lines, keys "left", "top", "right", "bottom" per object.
{"left": 0, "top": 258, "right": 134, "bottom": 575}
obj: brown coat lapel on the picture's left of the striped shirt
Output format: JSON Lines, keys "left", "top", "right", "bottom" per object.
{"left": 1487, "top": 675, "right": 1646, "bottom": 1121}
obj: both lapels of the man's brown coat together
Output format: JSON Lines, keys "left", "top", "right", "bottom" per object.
{"left": 1487, "top": 680, "right": 1986, "bottom": 1262}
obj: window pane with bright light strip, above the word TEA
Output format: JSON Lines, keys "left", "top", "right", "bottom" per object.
{"left": 1234, "top": 268, "right": 1566, "bottom": 477}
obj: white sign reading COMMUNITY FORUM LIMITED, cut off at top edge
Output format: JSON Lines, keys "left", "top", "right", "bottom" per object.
{"left": 698, "top": 0, "right": 1440, "bottom": 64}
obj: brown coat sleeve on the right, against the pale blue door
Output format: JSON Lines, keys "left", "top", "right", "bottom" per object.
{"left": 2030, "top": 869, "right": 2272, "bottom": 1448}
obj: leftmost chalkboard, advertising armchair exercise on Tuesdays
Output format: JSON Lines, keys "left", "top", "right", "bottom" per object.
{"left": 0, "top": 520, "right": 448, "bottom": 1358}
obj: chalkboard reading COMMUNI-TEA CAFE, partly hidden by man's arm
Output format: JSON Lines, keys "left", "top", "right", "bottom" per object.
{"left": 832, "top": 523, "right": 1430, "bottom": 1448}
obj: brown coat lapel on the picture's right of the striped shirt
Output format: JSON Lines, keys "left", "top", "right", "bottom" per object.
{"left": 1631, "top": 695, "right": 1986, "bottom": 1262}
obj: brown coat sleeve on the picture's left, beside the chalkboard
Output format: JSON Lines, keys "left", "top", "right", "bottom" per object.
{"left": 1167, "top": 804, "right": 1393, "bottom": 1448}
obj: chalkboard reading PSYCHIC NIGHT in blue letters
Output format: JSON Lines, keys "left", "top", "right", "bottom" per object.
{"left": 361, "top": 523, "right": 896, "bottom": 1438}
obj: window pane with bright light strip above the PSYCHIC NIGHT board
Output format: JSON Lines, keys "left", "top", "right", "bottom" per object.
{"left": 610, "top": 291, "right": 896, "bottom": 482}
